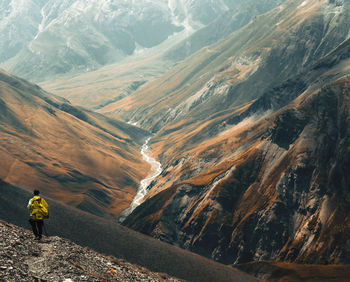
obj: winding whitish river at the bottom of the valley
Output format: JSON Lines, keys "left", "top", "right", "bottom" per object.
{"left": 119, "top": 137, "right": 162, "bottom": 222}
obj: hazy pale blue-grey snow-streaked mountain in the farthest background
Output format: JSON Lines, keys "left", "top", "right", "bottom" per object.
{"left": 0, "top": 0, "right": 241, "bottom": 81}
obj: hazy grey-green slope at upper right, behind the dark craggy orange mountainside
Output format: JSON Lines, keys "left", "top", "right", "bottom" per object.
{"left": 101, "top": 0, "right": 350, "bottom": 131}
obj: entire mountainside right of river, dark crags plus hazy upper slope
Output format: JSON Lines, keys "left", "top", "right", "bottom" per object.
{"left": 119, "top": 1, "right": 350, "bottom": 264}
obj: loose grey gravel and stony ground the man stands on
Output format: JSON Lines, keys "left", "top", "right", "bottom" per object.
{"left": 0, "top": 220, "right": 182, "bottom": 282}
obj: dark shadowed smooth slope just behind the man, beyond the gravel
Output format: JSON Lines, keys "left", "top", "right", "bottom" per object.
{"left": 0, "top": 181, "right": 255, "bottom": 281}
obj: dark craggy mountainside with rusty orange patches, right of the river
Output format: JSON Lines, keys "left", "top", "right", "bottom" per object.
{"left": 125, "top": 37, "right": 350, "bottom": 264}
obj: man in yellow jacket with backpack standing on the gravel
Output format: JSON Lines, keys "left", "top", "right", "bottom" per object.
{"left": 27, "top": 190, "right": 48, "bottom": 240}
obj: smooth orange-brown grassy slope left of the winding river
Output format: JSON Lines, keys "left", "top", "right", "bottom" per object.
{"left": 0, "top": 71, "right": 148, "bottom": 216}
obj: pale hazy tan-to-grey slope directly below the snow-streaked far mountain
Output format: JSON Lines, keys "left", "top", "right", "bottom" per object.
{"left": 41, "top": 0, "right": 283, "bottom": 112}
